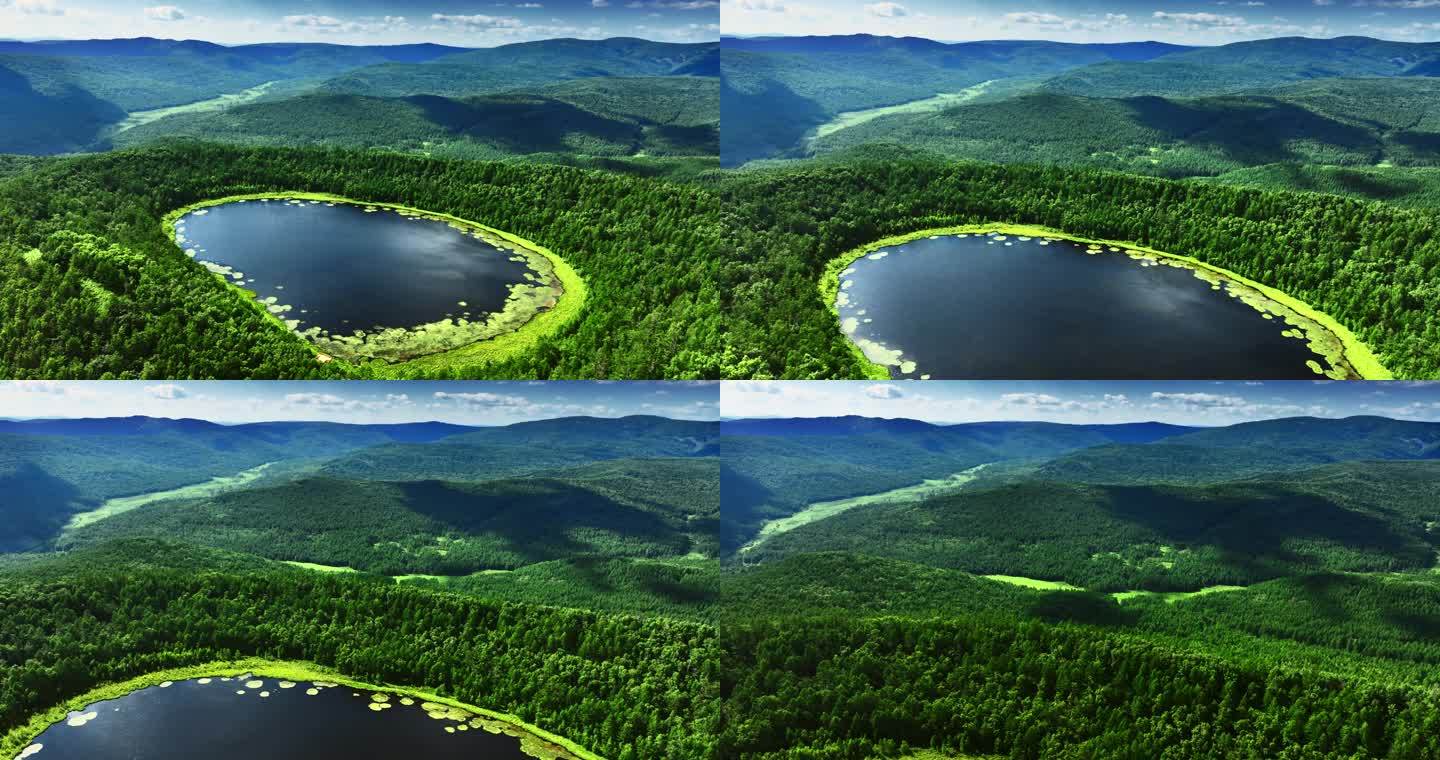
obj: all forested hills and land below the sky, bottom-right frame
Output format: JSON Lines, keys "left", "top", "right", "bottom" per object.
{"left": 719, "top": 417, "right": 1440, "bottom": 760}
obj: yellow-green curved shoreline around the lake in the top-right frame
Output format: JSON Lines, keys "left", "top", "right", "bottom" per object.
{"left": 818, "top": 223, "right": 1394, "bottom": 380}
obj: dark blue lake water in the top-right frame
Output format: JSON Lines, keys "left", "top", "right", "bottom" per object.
{"left": 840, "top": 235, "right": 1329, "bottom": 380}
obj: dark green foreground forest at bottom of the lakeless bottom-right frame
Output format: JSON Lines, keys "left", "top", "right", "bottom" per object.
{"left": 721, "top": 618, "right": 1440, "bottom": 760}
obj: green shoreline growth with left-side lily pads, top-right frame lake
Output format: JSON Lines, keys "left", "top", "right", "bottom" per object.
{"left": 819, "top": 223, "right": 1392, "bottom": 380}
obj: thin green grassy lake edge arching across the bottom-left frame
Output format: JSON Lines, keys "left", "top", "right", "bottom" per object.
{"left": 0, "top": 658, "right": 605, "bottom": 760}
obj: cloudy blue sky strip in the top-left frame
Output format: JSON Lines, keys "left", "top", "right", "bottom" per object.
{"left": 0, "top": 0, "right": 720, "bottom": 48}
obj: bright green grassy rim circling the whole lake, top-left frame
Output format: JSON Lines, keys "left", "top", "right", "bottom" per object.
{"left": 160, "top": 190, "right": 586, "bottom": 379}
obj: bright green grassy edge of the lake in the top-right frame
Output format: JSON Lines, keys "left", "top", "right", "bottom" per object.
{"left": 818, "top": 222, "right": 1394, "bottom": 380}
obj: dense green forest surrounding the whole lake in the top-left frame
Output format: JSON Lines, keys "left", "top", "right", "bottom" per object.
{"left": 0, "top": 144, "right": 723, "bottom": 379}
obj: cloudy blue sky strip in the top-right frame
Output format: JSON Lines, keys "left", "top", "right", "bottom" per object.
{"left": 720, "top": 0, "right": 1440, "bottom": 45}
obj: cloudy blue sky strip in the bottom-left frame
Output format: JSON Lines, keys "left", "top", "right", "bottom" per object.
{"left": 0, "top": 380, "right": 720, "bottom": 425}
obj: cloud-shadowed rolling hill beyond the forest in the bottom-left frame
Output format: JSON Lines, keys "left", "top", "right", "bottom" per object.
{"left": 60, "top": 461, "right": 719, "bottom": 576}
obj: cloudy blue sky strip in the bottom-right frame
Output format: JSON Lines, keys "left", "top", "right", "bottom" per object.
{"left": 720, "top": 380, "right": 1440, "bottom": 426}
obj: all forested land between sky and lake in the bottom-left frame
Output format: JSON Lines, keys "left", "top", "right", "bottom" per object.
{"left": 0, "top": 416, "right": 720, "bottom": 760}
